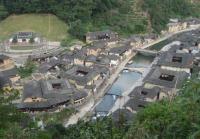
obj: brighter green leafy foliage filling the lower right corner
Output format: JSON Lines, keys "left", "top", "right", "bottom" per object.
{"left": 127, "top": 79, "right": 200, "bottom": 139}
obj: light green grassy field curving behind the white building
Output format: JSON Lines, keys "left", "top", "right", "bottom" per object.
{"left": 0, "top": 14, "right": 69, "bottom": 41}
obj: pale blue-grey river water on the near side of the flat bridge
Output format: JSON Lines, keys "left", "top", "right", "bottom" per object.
{"left": 95, "top": 54, "right": 154, "bottom": 116}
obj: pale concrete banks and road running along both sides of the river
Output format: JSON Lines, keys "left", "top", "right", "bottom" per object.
{"left": 64, "top": 25, "right": 200, "bottom": 127}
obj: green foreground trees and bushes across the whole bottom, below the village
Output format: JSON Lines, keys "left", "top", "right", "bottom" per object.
{"left": 0, "top": 79, "right": 200, "bottom": 139}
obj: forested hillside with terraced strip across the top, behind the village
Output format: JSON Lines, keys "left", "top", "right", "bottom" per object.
{"left": 0, "top": 0, "right": 200, "bottom": 39}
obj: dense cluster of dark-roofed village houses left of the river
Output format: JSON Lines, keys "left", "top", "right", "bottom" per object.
{"left": 2, "top": 31, "right": 161, "bottom": 111}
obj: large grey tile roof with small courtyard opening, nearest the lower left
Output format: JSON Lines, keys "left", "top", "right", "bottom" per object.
{"left": 23, "top": 79, "right": 73, "bottom": 107}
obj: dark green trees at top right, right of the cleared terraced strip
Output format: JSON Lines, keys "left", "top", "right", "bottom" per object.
{"left": 143, "top": 0, "right": 200, "bottom": 32}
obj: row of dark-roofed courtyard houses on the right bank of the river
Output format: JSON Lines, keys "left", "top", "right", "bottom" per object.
{"left": 112, "top": 29, "right": 200, "bottom": 122}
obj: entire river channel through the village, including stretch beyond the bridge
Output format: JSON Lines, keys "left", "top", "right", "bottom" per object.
{"left": 95, "top": 27, "right": 191, "bottom": 117}
